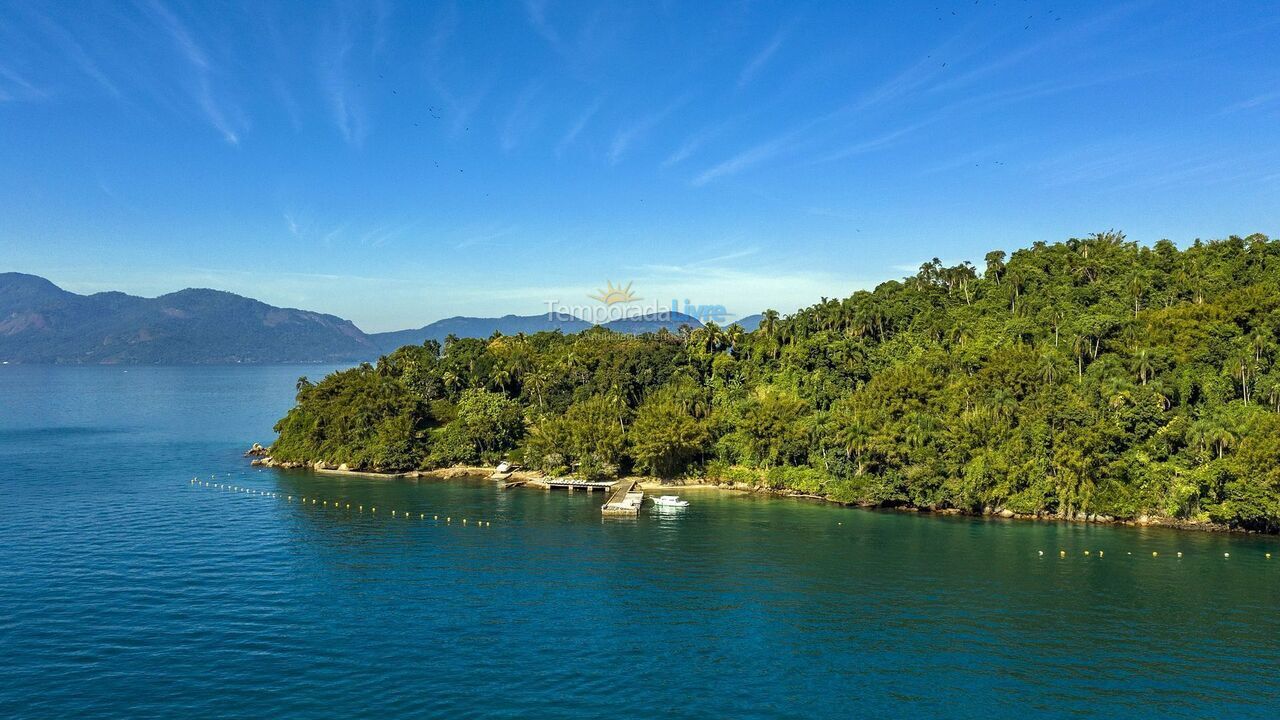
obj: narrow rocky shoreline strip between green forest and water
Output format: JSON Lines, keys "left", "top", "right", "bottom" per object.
{"left": 244, "top": 442, "right": 1257, "bottom": 534}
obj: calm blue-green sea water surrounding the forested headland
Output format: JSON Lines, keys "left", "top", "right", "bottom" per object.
{"left": 0, "top": 365, "right": 1280, "bottom": 719}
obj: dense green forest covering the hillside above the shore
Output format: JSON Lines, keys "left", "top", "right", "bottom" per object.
{"left": 271, "top": 232, "right": 1280, "bottom": 532}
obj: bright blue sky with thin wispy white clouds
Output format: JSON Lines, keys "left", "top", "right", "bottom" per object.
{"left": 0, "top": 0, "right": 1280, "bottom": 331}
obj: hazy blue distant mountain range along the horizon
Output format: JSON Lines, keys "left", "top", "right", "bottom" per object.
{"left": 0, "top": 273, "right": 721, "bottom": 365}
